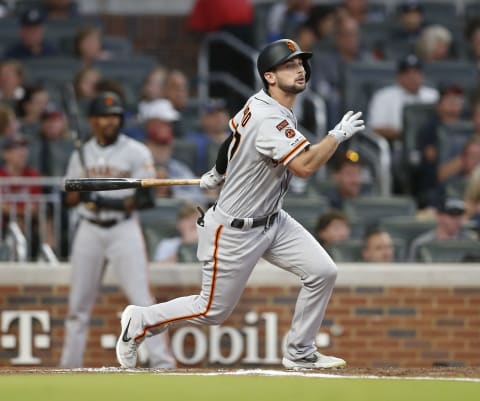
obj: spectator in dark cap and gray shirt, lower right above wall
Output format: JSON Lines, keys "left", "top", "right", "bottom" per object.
{"left": 408, "top": 197, "right": 476, "bottom": 262}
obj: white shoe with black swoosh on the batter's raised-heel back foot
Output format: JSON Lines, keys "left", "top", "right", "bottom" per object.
{"left": 116, "top": 305, "right": 139, "bottom": 368}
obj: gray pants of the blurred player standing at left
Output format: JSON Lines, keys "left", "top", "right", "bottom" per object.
{"left": 60, "top": 218, "right": 176, "bottom": 368}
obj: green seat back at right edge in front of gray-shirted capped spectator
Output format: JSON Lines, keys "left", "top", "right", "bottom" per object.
{"left": 418, "top": 240, "right": 480, "bottom": 263}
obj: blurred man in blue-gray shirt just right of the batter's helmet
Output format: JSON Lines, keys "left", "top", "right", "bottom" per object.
{"left": 311, "top": 17, "right": 372, "bottom": 127}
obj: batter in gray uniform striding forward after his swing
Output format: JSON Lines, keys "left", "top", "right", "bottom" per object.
{"left": 116, "top": 39, "right": 364, "bottom": 369}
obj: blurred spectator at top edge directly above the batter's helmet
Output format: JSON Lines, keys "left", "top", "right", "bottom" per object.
{"left": 266, "top": 0, "right": 312, "bottom": 43}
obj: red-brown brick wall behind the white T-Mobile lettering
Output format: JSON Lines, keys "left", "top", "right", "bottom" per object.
{"left": 0, "top": 285, "right": 480, "bottom": 367}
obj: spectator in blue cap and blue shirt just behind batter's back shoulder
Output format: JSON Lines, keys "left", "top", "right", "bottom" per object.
{"left": 186, "top": 99, "right": 230, "bottom": 173}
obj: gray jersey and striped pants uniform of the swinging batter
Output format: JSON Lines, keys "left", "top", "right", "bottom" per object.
{"left": 126, "top": 91, "right": 337, "bottom": 360}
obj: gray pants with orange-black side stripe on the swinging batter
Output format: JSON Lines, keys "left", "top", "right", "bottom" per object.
{"left": 133, "top": 206, "right": 337, "bottom": 359}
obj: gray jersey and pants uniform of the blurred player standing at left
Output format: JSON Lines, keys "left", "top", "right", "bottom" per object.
{"left": 60, "top": 135, "right": 175, "bottom": 368}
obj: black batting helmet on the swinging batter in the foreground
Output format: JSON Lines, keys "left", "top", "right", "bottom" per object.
{"left": 257, "top": 39, "right": 312, "bottom": 87}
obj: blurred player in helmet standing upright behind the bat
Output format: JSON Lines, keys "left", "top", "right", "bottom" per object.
{"left": 60, "top": 92, "right": 176, "bottom": 368}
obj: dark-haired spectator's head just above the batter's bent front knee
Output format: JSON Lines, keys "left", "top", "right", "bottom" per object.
{"left": 315, "top": 209, "right": 351, "bottom": 252}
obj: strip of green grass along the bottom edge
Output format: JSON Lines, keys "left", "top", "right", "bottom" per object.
{"left": 0, "top": 372, "right": 480, "bottom": 401}
